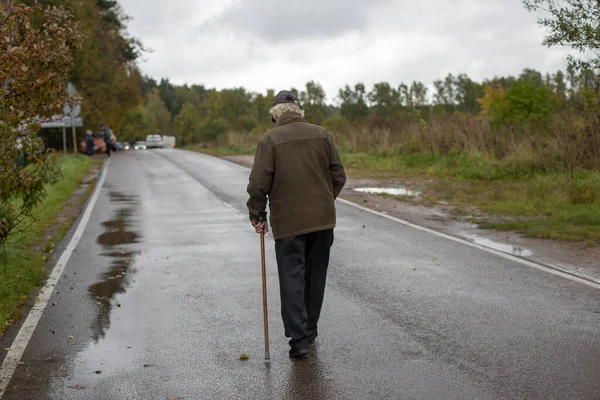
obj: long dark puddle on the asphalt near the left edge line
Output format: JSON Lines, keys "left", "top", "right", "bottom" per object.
{"left": 88, "top": 191, "right": 141, "bottom": 342}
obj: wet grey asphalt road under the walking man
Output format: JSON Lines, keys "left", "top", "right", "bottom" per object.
{"left": 3, "top": 150, "right": 600, "bottom": 400}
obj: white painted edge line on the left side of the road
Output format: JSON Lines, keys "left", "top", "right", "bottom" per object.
{"left": 0, "top": 159, "right": 110, "bottom": 399}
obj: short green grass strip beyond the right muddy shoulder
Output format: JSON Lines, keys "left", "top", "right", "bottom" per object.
{"left": 340, "top": 148, "right": 600, "bottom": 242}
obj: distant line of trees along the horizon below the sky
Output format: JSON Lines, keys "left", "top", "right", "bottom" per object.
{"left": 121, "top": 68, "right": 600, "bottom": 155}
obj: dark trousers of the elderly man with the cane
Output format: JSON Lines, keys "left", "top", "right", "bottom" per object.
{"left": 275, "top": 229, "right": 333, "bottom": 348}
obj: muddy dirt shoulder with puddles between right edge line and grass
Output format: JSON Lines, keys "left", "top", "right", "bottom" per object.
{"left": 221, "top": 156, "right": 600, "bottom": 283}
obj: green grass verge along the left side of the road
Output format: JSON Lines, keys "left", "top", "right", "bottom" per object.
{"left": 0, "top": 155, "right": 98, "bottom": 334}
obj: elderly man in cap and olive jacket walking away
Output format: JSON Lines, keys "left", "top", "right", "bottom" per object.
{"left": 247, "top": 90, "right": 346, "bottom": 358}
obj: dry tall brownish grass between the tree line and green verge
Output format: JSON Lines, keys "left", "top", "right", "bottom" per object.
{"left": 217, "top": 113, "right": 600, "bottom": 172}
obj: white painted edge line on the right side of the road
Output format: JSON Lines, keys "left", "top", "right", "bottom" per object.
{"left": 337, "top": 197, "right": 600, "bottom": 290}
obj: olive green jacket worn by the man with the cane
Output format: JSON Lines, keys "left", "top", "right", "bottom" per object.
{"left": 247, "top": 114, "right": 346, "bottom": 240}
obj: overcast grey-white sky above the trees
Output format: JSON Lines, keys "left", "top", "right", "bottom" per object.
{"left": 120, "top": 0, "right": 567, "bottom": 101}
